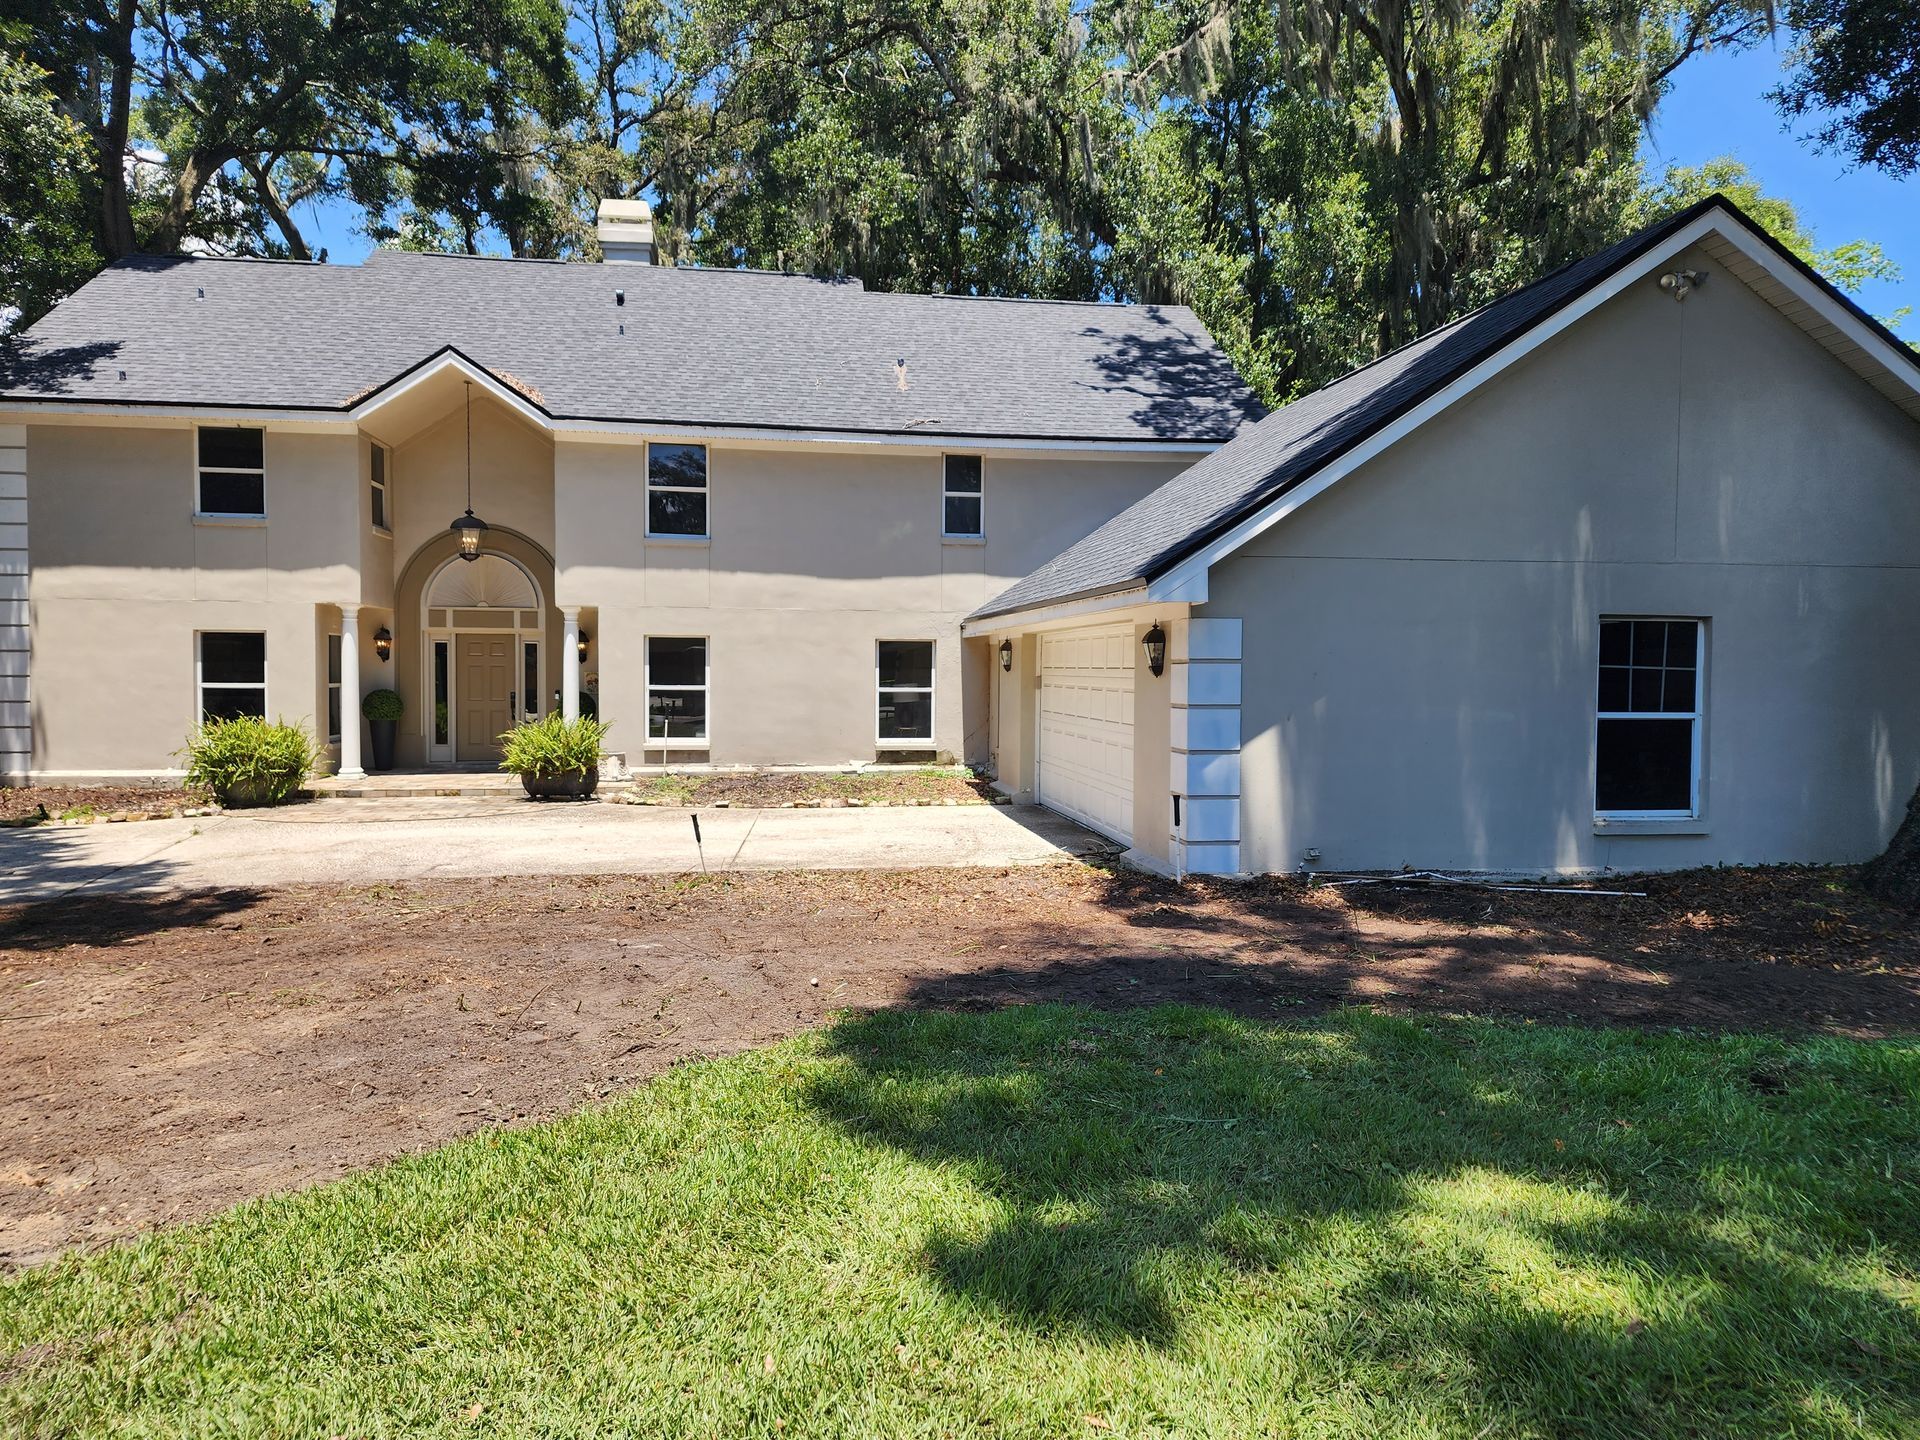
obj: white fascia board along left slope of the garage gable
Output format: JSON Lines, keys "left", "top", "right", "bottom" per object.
{"left": 1146, "top": 211, "right": 1751, "bottom": 605}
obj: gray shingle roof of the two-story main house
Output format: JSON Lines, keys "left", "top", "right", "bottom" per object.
{"left": 0, "top": 250, "right": 1261, "bottom": 442}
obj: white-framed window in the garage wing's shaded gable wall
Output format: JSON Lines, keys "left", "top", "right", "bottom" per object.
{"left": 1594, "top": 616, "right": 1707, "bottom": 820}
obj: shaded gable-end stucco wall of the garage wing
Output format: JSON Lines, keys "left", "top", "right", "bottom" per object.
{"left": 1196, "top": 255, "right": 1920, "bottom": 872}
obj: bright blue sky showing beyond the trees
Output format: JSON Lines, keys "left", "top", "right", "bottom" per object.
{"left": 301, "top": 36, "right": 1920, "bottom": 330}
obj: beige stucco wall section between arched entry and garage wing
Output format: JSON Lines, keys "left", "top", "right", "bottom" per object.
{"left": 555, "top": 440, "right": 1187, "bottom": 764}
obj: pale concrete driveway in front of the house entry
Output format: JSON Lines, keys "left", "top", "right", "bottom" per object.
{"left": 0, "top": 799, "right": 1116, "bottom": 902}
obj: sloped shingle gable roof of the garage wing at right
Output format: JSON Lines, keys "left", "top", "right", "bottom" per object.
{"left": 968, "top": 196, "right": 1920, "bottom": 622}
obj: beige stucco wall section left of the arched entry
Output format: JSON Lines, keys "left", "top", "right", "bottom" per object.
{"left": 27, "top": 424, "right": 361, "bottom": 776}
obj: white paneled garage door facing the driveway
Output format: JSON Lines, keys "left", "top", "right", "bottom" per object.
{"left": 1039, "top": 624, "right": 1135, "bottom": 845}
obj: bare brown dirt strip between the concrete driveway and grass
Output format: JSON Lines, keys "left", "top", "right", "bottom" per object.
{"left": 0, "top": 866, "right": 1920, "bottom": 1265}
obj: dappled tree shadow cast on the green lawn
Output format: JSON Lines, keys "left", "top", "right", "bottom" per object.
{"left": 812, "top": 1008, "right": 1920, "bottom": 1434}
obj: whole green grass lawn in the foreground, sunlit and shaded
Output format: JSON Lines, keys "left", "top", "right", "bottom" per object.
{"left": 0, "top": 1008, "right": 1920, "bottom": 1440}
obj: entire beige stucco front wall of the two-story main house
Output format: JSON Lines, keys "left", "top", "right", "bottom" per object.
{"left": 15, "top": 397, "right": 1187, "bottom": 774}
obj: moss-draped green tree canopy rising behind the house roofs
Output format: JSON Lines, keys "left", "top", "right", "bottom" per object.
{"left": 0, "top": 0, "right": 1887, "bottom": 401}
